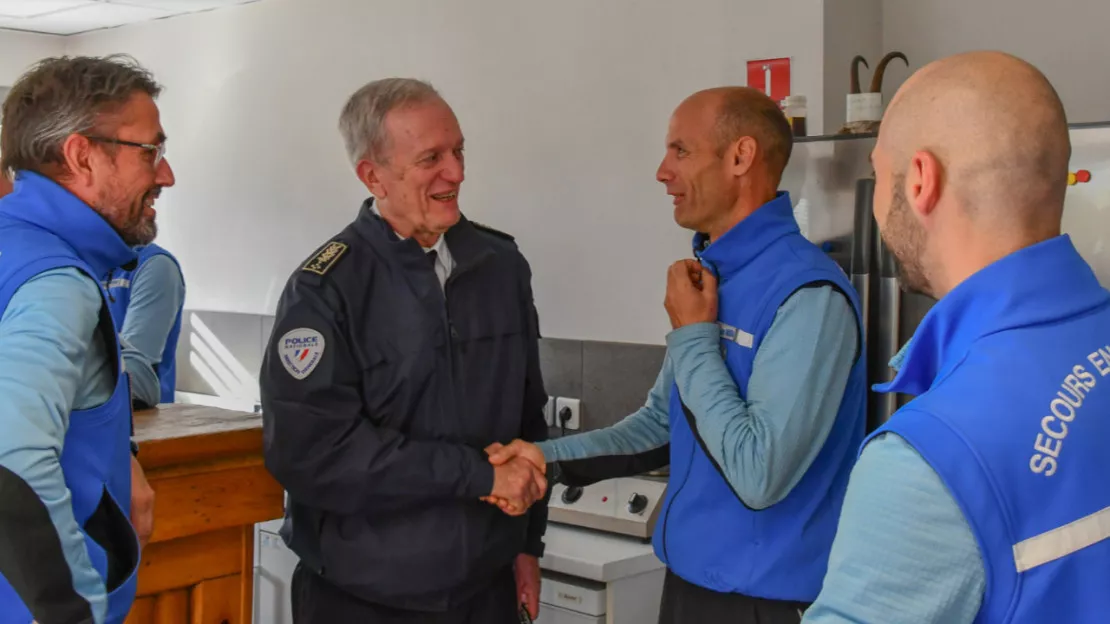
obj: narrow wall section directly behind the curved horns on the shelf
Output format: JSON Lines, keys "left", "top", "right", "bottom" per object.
{"left": 824, "top": 0, "right": 883, "bottom": 129}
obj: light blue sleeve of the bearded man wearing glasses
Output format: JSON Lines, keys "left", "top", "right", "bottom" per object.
{"left": 0, "top": 269, "right": 114, "bottom": 623}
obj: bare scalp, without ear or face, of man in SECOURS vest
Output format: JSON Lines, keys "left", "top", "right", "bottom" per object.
{"left": 879, "top": 52, "right": 1071, "bottom": 228}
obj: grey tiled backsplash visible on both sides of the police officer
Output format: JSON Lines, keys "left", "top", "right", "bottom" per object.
{"left": 178, "top": 310, "right": 665, "bottom": 430}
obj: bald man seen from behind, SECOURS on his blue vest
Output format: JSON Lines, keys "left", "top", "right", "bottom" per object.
{"left": 806, "top": 52, "right": 1110, "bottom": 624}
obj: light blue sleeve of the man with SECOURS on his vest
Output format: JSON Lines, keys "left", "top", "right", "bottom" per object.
{"left": 804, "top": 343, "right": 987, "bottom": 624}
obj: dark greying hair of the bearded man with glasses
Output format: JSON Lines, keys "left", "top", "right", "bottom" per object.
{"left": 0, "top": 54, "right": 162, "bottom": 173}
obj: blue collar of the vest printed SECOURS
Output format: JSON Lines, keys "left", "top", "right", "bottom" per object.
{"left": 875, "top": 234, "right": 1110, "bottom": 395}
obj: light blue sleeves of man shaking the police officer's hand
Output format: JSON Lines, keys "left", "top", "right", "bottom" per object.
{"left": 539, "top": 285, "right": 859, "bottom": 509}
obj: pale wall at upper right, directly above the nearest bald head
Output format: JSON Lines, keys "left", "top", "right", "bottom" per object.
{"left": 882, "top": 0, "right": 1110, "bottom": 122}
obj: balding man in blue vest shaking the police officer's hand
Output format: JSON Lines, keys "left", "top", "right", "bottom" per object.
{"left": 490, "top": 88, "right": 866, "bottom": 624}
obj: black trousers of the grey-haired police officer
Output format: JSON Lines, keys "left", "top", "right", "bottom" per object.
{"left": 290, "top": 564, "right": 519, "bottom": 624}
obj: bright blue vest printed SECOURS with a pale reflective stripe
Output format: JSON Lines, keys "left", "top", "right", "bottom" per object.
{"left": 872, "top": 235, "right": 1110, "bottom": 623}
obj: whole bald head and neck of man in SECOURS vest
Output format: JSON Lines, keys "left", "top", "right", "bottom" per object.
{"left": 871, "top": 52, "right": 1071, "bottom": 298}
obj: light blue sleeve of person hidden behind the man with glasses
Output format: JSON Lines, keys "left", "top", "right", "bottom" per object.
{"left": 120, "top": 254, "right": 185, "bottom": 405}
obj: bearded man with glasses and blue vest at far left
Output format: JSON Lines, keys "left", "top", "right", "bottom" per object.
{"left": 0, "top": 57, "right": 174, "bottom": 624}
